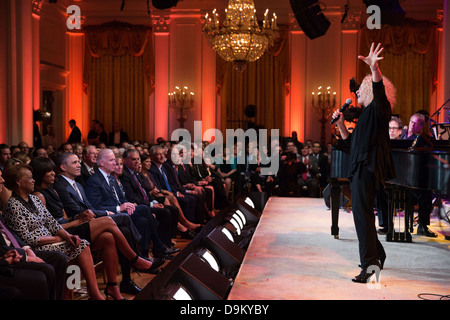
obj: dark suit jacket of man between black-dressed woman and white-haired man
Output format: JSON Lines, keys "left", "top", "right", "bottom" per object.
{"left": 53, "top": 176, "right": 108, "bottom": 218}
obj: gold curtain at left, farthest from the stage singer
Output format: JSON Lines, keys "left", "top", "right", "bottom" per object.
{"left": 80, "top": 22, "right": 154, "bottom": 140}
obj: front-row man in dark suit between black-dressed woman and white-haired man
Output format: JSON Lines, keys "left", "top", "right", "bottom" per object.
{"left": 53, "top": 153, "right": 142, "bottom": 294}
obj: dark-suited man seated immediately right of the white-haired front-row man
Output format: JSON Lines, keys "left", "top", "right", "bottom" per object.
{"left": 120, "top": 149, "right": 178, "bottom": 247}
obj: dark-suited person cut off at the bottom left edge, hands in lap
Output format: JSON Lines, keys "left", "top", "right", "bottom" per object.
{"left": 0, "top": 171, "right": 67, "bottom": 300}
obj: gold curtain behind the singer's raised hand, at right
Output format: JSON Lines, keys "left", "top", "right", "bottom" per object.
{"left": 358, "top": 21, "right": 437, "bottom": 125}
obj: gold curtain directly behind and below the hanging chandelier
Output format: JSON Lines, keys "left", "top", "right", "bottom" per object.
{"left": 217, "top": 31, "right": 289, "bottom": 133}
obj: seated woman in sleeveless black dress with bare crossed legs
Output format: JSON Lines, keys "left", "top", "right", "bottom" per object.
{"left": 31, "top": 154, "right": 156, "bottom": 299}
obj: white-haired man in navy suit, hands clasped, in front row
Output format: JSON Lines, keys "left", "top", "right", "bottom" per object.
{"left": 85, "top": 149, "right": 171, "bottom": 259}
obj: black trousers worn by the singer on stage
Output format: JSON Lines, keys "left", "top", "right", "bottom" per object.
{"left": 350, "top": 163, "right": 386, "bottom": 268}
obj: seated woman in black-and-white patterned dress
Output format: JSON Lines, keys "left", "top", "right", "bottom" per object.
{"left": 4, "top": 164, "right": 104, "bottom": 300}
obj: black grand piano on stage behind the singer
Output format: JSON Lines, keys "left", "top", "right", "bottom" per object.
{"left": 330, "top": 139, "right": 450, "bottom": 242}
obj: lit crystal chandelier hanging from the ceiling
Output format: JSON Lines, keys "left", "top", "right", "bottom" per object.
{"left": 203, "top": 0, "right": 278, "bottom": 71}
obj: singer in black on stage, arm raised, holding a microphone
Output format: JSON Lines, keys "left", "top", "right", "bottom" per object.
{"left": 332, "top": 43, "right": 395, "bottom": 283}
